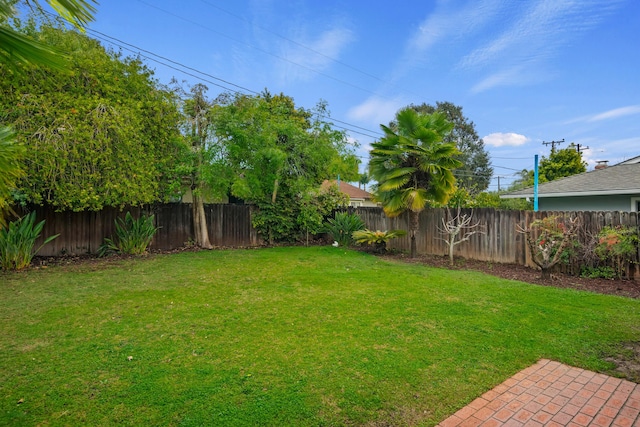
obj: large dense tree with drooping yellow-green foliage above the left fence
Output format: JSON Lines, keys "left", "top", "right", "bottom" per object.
{"left": 0, "top": 25, "right": 183, "bottom": 211}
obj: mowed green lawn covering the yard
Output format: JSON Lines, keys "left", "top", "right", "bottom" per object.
{"left": 0, "top": 247, "right": 640, "bottom": 426}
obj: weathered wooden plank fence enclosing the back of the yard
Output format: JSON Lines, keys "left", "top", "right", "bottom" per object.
{"left": 25, "top": 203, "right": 640, "bottom": 277}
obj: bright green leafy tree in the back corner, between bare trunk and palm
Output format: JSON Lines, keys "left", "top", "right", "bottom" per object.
{"left": 213, "top": 91, "right": 358, "bottom": 242}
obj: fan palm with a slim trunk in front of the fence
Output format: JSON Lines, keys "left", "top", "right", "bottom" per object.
{"left": 369, "top": 108, "right": 462, "bottom": 258}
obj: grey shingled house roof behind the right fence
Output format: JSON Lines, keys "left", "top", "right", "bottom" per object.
{"left": 500, "top": 161, "right": 640, "bottom": 199}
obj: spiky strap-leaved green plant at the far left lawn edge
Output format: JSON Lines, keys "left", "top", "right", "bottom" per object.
{"left": 0, "top": 212, "right": 59, "bottom": 270}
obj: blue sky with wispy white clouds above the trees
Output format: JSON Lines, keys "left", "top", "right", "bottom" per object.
{"left": 89, "top": 0, "right": 640, "bottom": 190}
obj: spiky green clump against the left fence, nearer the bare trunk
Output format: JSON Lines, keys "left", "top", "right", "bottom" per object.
{"left": 98, "top": 212, "right": 158, "bottom": 256}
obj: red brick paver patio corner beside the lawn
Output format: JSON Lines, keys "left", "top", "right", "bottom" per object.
{"left": 438, "top": 359, "right": 640, "bottom": 427}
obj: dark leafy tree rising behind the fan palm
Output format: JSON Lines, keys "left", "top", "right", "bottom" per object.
{"left": 402, "top": 102, "right": 493, "bottom": 194}
